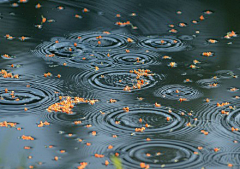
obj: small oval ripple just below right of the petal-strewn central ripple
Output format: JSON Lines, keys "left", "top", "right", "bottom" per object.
{"left": 154, "top": 84, "right": 202, "bottom": 100}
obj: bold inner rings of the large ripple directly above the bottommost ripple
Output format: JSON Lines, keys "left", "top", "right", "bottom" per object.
{"left": 93, "top": 108, "right": 184, "bottom": 134}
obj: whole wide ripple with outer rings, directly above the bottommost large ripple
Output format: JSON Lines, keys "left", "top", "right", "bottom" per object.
{"left": 87, "top": 106, "right": 198, "bottom": 136}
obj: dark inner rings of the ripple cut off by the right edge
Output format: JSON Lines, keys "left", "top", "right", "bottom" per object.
{"left": 221, "top": 109, "right": 240, "bottom": 135}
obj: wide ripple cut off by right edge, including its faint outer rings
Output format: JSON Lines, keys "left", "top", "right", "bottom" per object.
{"left": 195, "top": 100, "right": 240, "bottom": 140}
